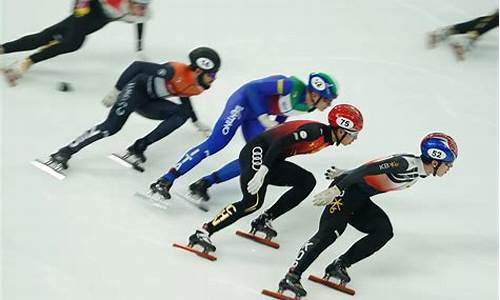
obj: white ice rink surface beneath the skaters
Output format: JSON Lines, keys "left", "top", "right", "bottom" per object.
{"left": 0, "top": 0, "right": 499, "bottom": 300}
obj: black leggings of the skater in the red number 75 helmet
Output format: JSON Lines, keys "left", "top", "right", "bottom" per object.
{"left": 204, "top": 142, "right": 316, "bottom": 234}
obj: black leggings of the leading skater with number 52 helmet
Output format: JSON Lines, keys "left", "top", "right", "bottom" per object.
{"left": 291, "top": 186, "right": 393, "bottom": 275}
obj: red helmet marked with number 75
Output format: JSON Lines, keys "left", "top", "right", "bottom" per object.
{"left": 328, "top": 104, "right": 363, "bottom": 132}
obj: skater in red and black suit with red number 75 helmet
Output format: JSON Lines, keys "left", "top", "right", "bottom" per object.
{"left": 184, "top": 104, "right": 363, "bottom": 290}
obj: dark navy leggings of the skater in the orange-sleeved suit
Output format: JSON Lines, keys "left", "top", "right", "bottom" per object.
{"left": 59, "top": 75, "right": 190, "bottom": 155}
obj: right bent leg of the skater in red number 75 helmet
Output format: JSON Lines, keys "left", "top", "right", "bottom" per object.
{"left": 266, "top": 161, "right": 316, "bottom": 220}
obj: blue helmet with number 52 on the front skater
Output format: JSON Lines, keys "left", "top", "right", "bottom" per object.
{"left": 420, "top": 132, "right": 458, "bottom": 163}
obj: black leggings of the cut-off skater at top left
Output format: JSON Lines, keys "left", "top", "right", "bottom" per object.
{"left": 2, "top": 0, "right": 111, "bottom": 63}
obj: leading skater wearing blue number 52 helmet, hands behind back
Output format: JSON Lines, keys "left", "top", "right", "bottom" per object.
{"left": 279, "top": 133, "right": 458, "bottom": 295}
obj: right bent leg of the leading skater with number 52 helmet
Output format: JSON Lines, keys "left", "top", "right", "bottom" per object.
{"left": 342, "top": 200, "right": 394, "bottom": 267}
